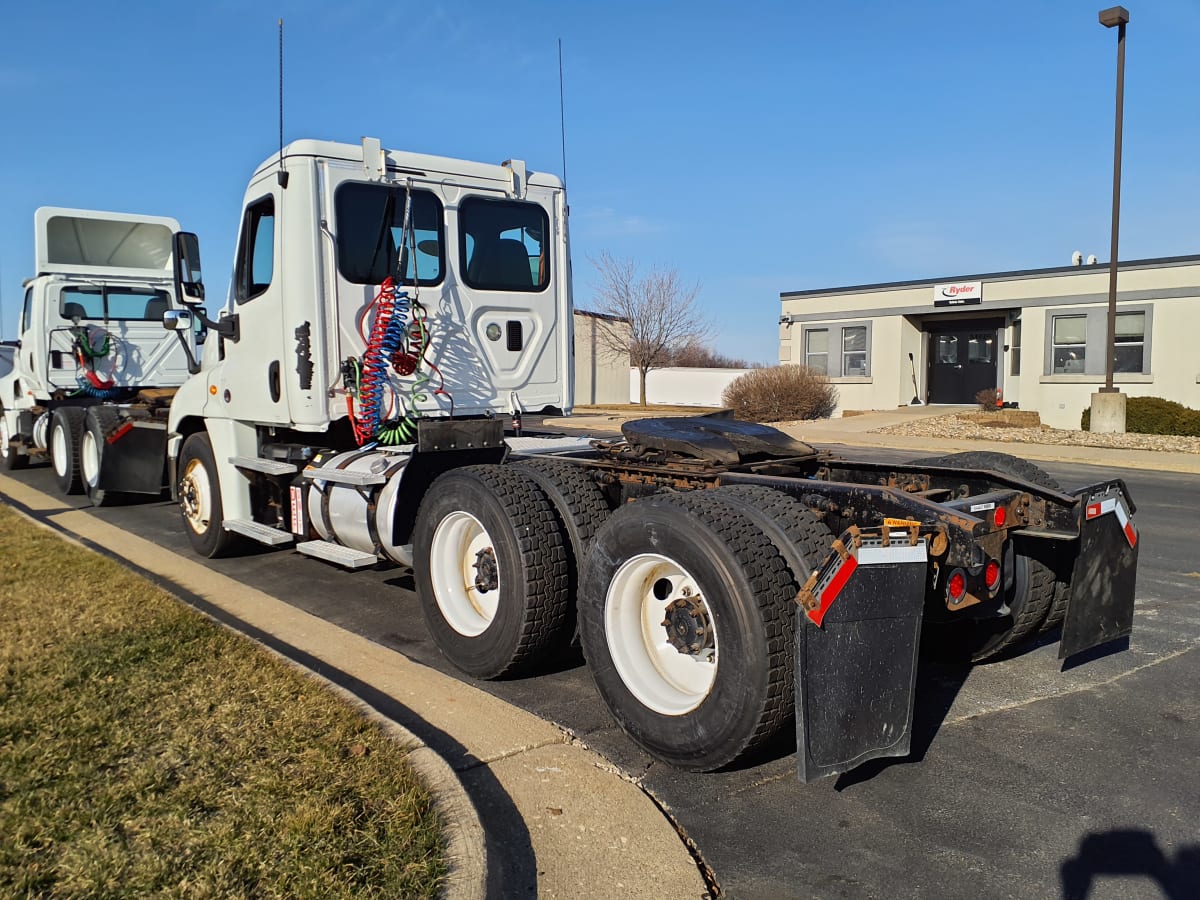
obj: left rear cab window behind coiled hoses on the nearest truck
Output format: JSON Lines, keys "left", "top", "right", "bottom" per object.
{"left": 334, "top": 187, "right": 445, "bottom": 284}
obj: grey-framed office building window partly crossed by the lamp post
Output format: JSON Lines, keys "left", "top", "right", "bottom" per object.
{"left": 1043, "top": 304, "right": 1154, "bottom": 378}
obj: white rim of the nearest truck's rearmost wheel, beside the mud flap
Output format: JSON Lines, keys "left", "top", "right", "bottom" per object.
{"left": 604, "top": 553, "right": 718, "bottom": 715}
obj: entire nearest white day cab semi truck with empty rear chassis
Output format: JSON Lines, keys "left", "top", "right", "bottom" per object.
{"left": 150, "top": 139, "right": 1138, "bottom": 780}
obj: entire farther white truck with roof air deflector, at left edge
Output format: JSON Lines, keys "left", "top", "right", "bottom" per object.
{"left": 0, "top": 206, "right": 197, "bottom": 505}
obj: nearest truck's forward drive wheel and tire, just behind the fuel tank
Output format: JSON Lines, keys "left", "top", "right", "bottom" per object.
{"left": 413, "top": 466, "right": 571, "bottom": 678}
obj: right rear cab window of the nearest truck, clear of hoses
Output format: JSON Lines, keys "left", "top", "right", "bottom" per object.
{"left": 458, "top": 197, "right": 550, "bottom": 290}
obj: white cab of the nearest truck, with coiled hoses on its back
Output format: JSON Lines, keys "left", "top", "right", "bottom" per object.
{"left": 168, "top": 138, "right": 572, "bottom": 535}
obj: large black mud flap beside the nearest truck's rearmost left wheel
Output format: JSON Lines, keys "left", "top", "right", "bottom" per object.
{"left": 796, "top": 535, "right": 929, "bottom": 782}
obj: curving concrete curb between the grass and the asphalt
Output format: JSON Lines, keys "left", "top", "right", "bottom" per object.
{"left": 0, "top": 475, "right": 709, "bottom": 900}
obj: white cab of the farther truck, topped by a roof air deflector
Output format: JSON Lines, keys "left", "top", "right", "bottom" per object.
{"left": 0, "top": 206, "right": 197, "bottom": 493}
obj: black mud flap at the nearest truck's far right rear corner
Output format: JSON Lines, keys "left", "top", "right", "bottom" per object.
{"left": 1058, "top": 479, "right": 1140, "bottom": 659}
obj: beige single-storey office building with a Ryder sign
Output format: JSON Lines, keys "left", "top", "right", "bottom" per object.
{"left": 779, "top": 256, "right": 1200, "bottom": 428}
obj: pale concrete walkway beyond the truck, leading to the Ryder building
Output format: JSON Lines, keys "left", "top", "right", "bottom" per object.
{"left": 545, "top": 407, "right": 1200, "bottom": 475}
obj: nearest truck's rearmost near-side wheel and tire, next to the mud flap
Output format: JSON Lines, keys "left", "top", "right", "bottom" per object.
{"left": 578, "top": 491, "right": 794, "bottom": 772}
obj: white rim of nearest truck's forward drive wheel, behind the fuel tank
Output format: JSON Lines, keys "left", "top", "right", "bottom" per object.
{"left": 430, "top": 511, "right": 500, "bottom": 637}
